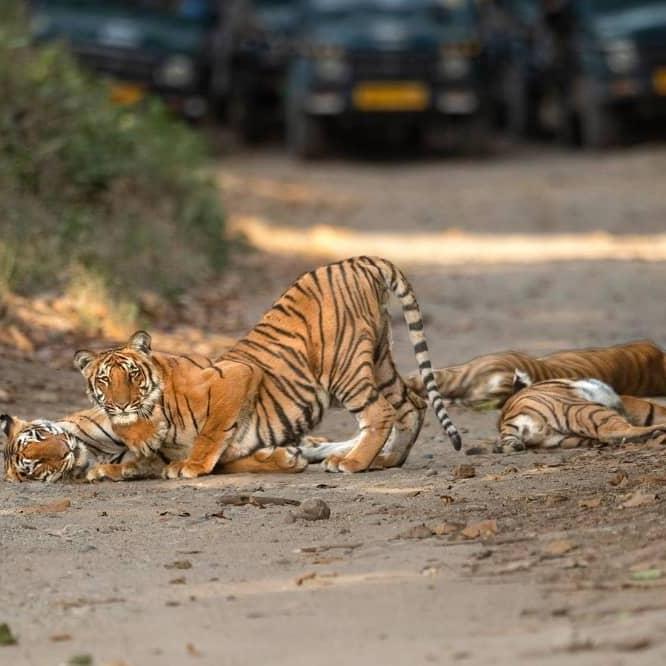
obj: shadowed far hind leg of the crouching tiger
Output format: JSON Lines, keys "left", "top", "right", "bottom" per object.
{"left": 372, "top": 341, "right": 427, "bottom": 469}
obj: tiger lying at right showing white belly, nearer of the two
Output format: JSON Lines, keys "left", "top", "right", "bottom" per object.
{"left": 493, "top": 371, "right": 666, "bottom": 453}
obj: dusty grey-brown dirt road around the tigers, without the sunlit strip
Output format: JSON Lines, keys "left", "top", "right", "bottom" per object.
{"left": 0, "top": 147, "right": 666, "bottom": 666}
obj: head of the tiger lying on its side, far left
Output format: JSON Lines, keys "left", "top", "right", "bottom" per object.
{"left": 0, "top": 414, "right": 88, "bottom": 482}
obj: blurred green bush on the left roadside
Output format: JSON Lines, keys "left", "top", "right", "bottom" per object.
{"left": 0, "top": 0, "right": 226, "bottom": 295}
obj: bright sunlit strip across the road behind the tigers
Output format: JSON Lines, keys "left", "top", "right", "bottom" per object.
{"left": 230, "top": 216, "right": 666, "bottom": 266}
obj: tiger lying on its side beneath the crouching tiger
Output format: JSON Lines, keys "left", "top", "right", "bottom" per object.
{"left": 0, "top": 408, "right": 308, "bottom": 482}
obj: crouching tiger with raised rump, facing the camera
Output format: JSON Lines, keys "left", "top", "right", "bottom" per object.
{"left": 75, "top": 257, "right": 461, "bottom": 478}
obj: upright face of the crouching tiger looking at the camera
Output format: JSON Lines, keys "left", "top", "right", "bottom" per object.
{"left": 74, "top": 331, "right": 162, "bottom": 425}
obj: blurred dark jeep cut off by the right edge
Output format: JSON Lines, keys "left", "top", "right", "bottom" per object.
{"left": 541, "top": 0, "right": 666, "bottom": 147}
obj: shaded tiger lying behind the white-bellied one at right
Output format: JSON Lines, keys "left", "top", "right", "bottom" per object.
{"left": 406, "top": 340, "right": 666, "bottom": 408}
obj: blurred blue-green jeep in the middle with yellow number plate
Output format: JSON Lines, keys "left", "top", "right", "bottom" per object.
{"left": 286, "top": 0, "right": 488, "bottom": 157}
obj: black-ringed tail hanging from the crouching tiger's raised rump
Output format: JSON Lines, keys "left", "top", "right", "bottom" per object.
{"left": 372, "top": 258, "right": 462, "bottom": 451}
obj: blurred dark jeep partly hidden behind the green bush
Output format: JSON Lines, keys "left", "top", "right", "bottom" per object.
{"left": 30, "top": 0, "right": 228, "bottom": 119}
